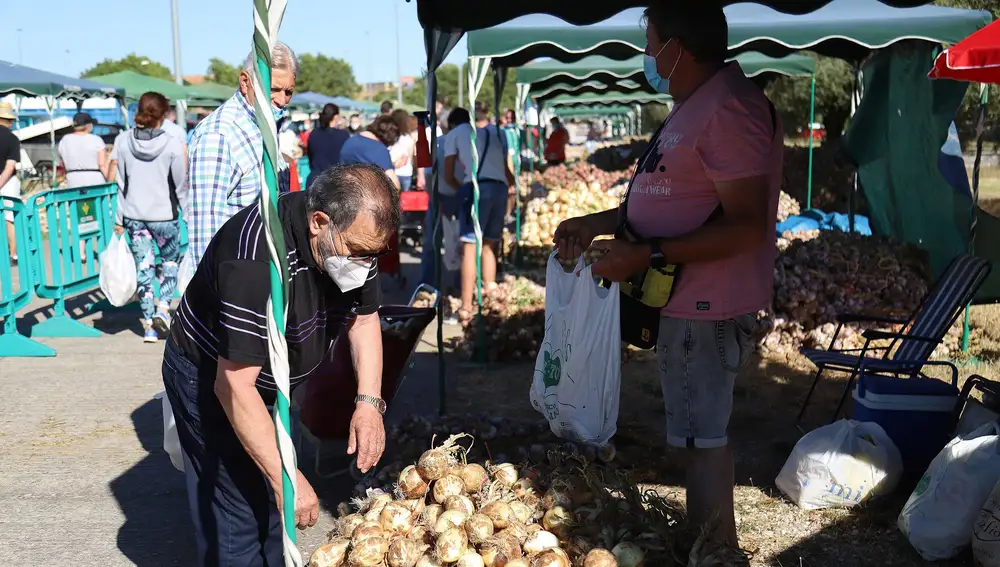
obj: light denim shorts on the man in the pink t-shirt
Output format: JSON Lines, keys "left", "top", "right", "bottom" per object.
{"left": 656, "top": 315, "right": 759, "bottom": 449}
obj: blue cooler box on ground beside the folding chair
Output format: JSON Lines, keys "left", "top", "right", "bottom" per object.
{"left": 851, "top": 375, "right": 959, "bottom": 475}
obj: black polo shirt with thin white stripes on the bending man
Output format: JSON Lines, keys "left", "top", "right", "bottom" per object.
{"left": 170, "top": 192, "right": 382, "bottom": 403}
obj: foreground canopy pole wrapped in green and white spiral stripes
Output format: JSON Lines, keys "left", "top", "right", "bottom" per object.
{"left": 251, "top": 0, "right": 302, "bottom": 567}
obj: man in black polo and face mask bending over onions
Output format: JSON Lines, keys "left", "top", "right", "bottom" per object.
{"left": 162, "top": 164, "right": 399, "bottom": 567}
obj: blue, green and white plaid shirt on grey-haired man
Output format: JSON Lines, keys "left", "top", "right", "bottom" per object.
{"left": 184, "top": 92, "right": 287, "bottom": 266}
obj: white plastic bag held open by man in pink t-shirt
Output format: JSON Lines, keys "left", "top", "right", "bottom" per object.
{"left": 530, "top": 254, "right": 621, "bottom": 446}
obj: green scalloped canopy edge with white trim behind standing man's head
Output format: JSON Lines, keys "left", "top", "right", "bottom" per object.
{"left": 467, "top": 0, "right": 992, "bottom": 67}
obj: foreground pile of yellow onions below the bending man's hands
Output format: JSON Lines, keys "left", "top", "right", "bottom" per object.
{"left": 309, "top": 434, "right": 663, "bottom": 567}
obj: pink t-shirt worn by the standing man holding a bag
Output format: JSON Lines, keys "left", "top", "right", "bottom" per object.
{"left": 628, "top": 63, "right": 784, "bottom": 320}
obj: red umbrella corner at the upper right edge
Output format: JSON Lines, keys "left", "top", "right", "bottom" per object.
{"left": 928, "top": 20, "right": 1000, "bottom": 85}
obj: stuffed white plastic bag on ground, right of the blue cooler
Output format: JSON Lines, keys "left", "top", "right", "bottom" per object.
{"left": 897, "top": 422, "right": 1000, "bottom": 561}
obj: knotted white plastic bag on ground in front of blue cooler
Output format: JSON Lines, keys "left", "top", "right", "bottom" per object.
{"left": 774, "top": 419, "right": 903, "bottom": 510}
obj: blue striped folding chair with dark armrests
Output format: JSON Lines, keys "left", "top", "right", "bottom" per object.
{"left": 795, "top": 254, "right": 991, "bottom": 425}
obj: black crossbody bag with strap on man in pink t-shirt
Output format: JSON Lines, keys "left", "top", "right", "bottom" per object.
{"left": 605, "top": 96, "right": 778, "bottom": 350}
